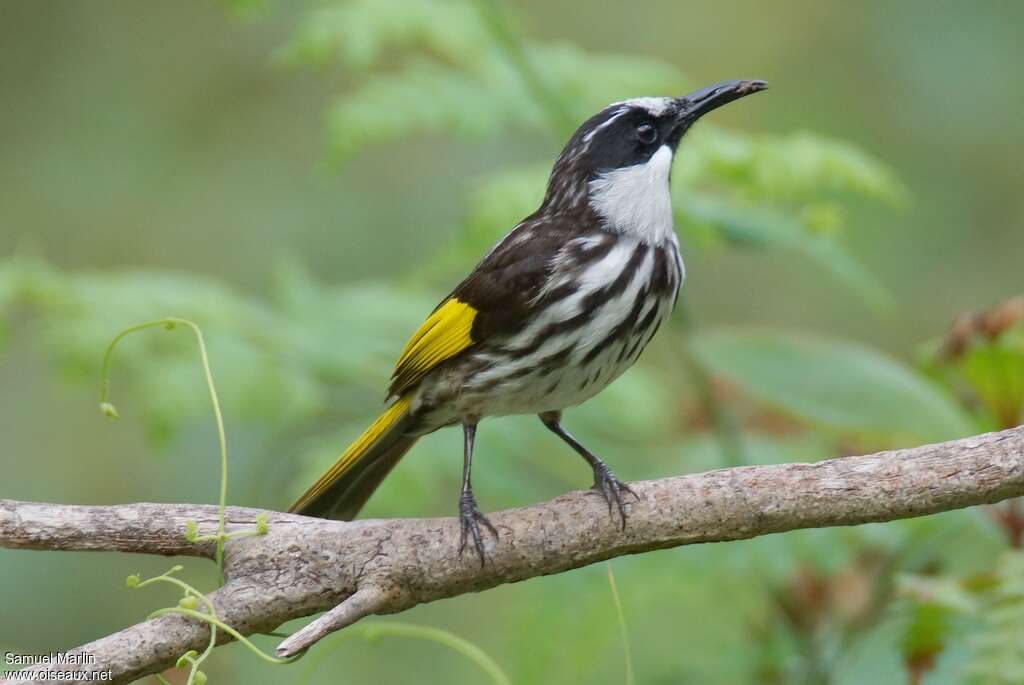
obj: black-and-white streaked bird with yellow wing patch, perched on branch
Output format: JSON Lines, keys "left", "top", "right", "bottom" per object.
{"left": 289, "top": 80, "right": 767, "bottom": 564}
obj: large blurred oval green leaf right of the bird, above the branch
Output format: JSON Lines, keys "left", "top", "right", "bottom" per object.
{"left": 692, "top": 330, "right": 972, "bottom": 440}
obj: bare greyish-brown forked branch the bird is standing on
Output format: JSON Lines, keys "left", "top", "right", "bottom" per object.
{"left": 0, "top": 427, "right": 1024, "bottom": 683}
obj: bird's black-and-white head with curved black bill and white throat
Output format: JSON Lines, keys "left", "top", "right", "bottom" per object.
{"left": 544, "top": 81, "right": 768, "bottom": 240}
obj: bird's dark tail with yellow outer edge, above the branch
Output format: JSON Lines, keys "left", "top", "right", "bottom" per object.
{"left": 288, "top": 393, "right": 418, "bottom": 521}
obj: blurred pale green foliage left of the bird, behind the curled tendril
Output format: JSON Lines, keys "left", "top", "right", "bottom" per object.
{"left": 0, "top": 253, "right": 433, "bottom": 440}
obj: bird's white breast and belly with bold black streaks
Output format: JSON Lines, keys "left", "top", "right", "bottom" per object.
{"left": 414, "top": 238, "right": 684, "bottom": 431}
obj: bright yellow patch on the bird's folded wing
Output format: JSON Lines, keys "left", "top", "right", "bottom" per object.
{"left": 390, "top": 297, "right": 477, "bottom": 395}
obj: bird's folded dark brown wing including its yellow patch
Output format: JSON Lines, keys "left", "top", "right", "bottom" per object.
{"left": 388, "top": 221, "right": 581, "bottom": 396}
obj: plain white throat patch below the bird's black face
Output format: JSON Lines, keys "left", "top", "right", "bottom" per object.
{"left": 589, "top": 145, "right": 675, "bottom": 245}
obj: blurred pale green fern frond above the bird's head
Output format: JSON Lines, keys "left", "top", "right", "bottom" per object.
{"left": 319, "top": 5, "right": 682, "bottom": 160}
